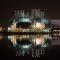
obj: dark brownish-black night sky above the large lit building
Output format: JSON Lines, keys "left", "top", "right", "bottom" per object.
{"left": 0, "top": 0, "right": 60, "bottom": 23}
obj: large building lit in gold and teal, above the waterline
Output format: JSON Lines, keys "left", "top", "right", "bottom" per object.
{"left": 8, "top": 9, "right": 50, "bottom": 32}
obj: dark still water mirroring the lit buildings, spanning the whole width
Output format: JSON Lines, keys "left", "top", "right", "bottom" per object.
{"left": 0, "top": 34, "right": 60, "bottom": 58}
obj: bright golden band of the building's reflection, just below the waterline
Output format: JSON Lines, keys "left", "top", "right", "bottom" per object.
{"left": 8, "top": 34, "right": 50, "bottom": 45}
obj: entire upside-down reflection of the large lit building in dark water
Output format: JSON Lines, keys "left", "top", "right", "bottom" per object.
{"left": 0, "top": 34, "right": 51, "bottom": 56}
